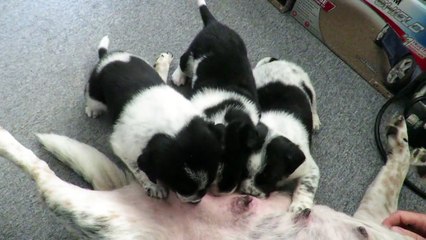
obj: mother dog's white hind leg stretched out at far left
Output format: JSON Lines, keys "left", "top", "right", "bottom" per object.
{"left": 0, "top": 128, "right": 123, "bottom": 239}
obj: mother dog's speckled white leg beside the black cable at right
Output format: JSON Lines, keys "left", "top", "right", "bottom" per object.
{"left": 354, "top": 116, "right": 410, "bottom": 224}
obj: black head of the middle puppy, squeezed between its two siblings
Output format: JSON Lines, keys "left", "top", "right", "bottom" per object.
{"left": 210, "top": 110, "right": 267, "bottom": 195}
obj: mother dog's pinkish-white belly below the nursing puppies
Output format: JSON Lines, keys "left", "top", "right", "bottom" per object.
{"left": 102, "top": 187, "right": 404, "bottom": 240}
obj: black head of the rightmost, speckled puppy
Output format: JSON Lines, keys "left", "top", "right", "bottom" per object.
{"left": 254, "top": 136, "right": 305, "bottom": 194}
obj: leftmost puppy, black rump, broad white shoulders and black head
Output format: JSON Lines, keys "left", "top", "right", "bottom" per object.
{"left": 86, "top": 37, "right": 223, "bottom": 203}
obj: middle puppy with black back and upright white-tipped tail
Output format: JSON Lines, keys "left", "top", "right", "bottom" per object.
{"left": 172, "top": 0, "right": 262, "bottom": 194}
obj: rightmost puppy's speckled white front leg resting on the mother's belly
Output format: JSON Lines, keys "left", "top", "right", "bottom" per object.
{"left": 289, "top": 160, "right": 320, "bottom": 213}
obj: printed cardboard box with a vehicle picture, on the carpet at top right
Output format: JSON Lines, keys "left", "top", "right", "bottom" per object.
{"left": 291, "top": 0, "right": 426, "bottom": 97}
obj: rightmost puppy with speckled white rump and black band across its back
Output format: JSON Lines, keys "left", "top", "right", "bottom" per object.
{"left": 240, "top": 58, "right": 320, "bottom": 212}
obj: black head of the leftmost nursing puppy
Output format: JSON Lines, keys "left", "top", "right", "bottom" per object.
{"left": 138, "top": 118, "right": 223, "bottom": 203}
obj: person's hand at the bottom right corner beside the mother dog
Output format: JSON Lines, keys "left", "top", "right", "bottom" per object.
{"left": 383, "top": 211, "right": 426, "bottom": 240}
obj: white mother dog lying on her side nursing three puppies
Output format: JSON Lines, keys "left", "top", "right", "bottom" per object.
{"left": 0, "top": 118, "right": 410, "bottom": 240}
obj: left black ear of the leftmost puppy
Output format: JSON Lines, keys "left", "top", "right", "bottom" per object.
{"left": 137, "top": 134, "right": 173, "bottom": 183}
